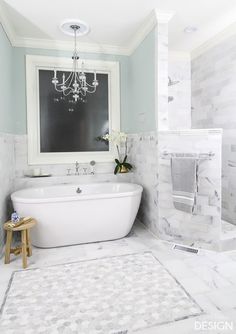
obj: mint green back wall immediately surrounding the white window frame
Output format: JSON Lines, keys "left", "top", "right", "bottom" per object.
{"left": 13, "top": 48, "right": 129, "bottom": 134}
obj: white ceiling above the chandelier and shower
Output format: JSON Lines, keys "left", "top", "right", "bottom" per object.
{"left": 0, "top": 0, "right": 236, "bottom": 52}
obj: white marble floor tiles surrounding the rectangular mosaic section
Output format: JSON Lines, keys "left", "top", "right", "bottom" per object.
{"left": 0, "top": 224, "right": 236, "bottom": 334}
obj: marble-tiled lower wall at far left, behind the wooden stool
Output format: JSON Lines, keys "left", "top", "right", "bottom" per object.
{"left": 0, "top": 133, "right": 15, "bottom": 257}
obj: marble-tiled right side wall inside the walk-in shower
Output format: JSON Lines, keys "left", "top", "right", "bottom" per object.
{"left": 191, "top": 35, "right": 236, "bottom": 224}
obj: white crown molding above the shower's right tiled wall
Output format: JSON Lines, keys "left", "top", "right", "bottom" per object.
{"left": 191, "top": 23, "right": 236, "bottom": 60}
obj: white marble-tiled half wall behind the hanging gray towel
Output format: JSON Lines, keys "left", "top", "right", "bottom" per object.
{"left": 158, "top": 129, "right": 222, "bottom": 250}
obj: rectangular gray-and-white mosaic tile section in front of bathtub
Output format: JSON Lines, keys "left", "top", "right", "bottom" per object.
{"left": 0, "top": 252, "right": 202, "bottom": 334}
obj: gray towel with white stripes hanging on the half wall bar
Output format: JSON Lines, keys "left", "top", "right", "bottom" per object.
{"left": 171, "top": 156, "right": 198, "bottom": 213}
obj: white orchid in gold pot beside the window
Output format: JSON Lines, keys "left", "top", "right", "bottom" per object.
{"left": 102, "top": 131, "right": 133, "bottom": 174}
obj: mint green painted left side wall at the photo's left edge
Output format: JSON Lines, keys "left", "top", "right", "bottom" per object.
{"left": 0, "top": 24, "right": 14, "bottom": 133}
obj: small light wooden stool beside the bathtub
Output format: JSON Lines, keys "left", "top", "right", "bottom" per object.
{"left": 4, "top": 218, "right": 36, "bottom": 268}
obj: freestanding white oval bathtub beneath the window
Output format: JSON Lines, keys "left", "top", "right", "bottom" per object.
{"left": 11, "top": 183, "right": 143, "bottom": 248}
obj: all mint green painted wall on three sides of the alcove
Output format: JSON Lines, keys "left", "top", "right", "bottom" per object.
{"left": 0, "top": 25, "right": 155, "bottom": 134}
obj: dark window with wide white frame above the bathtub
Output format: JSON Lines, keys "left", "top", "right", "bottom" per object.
{"left": 26, "top": 55, "right": 120, "bottom": 165}
